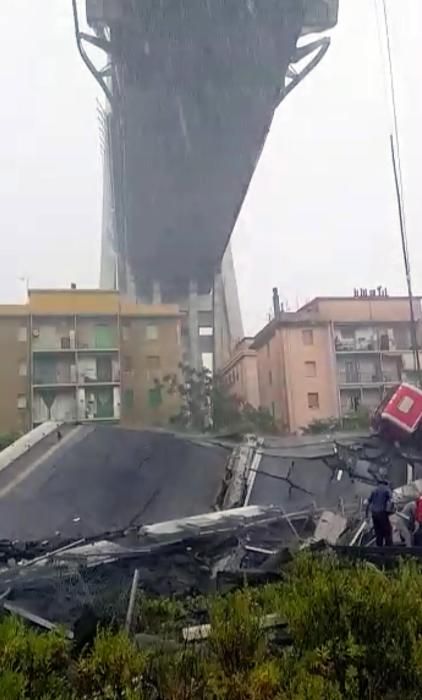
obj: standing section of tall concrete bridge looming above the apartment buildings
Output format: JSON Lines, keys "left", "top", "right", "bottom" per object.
{"left": 72, "top": 0, "right": 338, "bottom": 367}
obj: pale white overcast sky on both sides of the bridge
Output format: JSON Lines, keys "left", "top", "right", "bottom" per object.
{"left": 0, "top": 0, "right": 422, "bottom": 333}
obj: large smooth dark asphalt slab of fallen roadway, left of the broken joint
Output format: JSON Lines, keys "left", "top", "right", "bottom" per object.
{"left": 0, "top": 426, "right": 228, "bottom": 540}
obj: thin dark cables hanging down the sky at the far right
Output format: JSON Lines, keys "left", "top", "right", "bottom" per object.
{"left": 382, "top": 0, "right": 422, "bottom": 386}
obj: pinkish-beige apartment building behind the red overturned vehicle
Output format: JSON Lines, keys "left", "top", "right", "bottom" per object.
{"left": 224, "top": 293, "right": 422, "bottom": 432}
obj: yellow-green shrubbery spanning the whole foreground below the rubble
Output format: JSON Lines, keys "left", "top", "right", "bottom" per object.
{"left": 0, "top": 555, "right": 422, "bottom": 700}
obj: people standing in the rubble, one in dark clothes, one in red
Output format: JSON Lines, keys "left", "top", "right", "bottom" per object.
{"left": 366, "top": 479, "right": 422, "bottom": 547}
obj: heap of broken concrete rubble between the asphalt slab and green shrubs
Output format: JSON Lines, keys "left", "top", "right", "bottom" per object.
{"left": 0, "top": 386, "right": 422, "bottom": 636}
